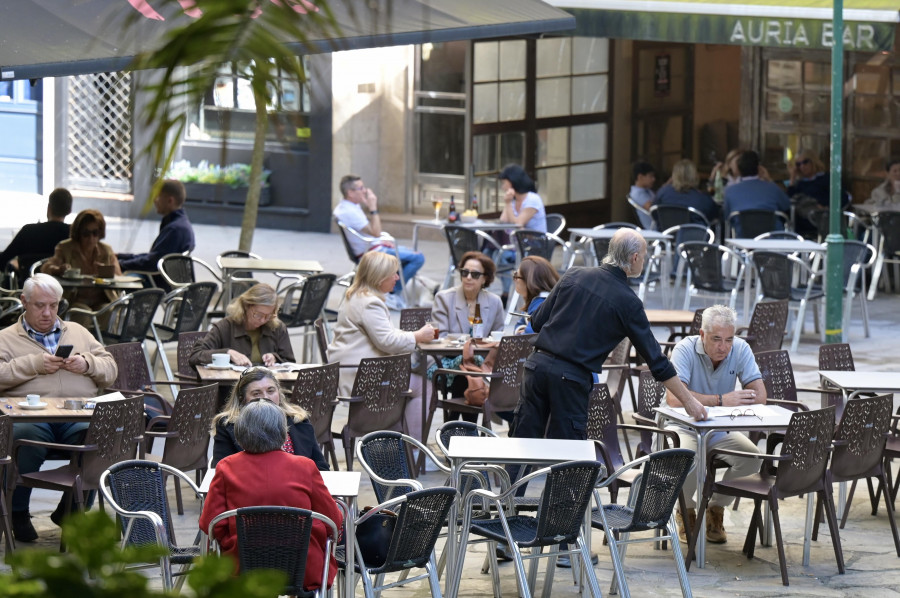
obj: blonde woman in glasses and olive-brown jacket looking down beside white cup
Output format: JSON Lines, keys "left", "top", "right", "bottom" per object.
{"left": 188, "top": 283, "right": 294, "bottom": 367}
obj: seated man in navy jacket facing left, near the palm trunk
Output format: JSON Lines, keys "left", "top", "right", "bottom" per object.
{"left": 116, "top": 179, "right": 194, "bottom": 288}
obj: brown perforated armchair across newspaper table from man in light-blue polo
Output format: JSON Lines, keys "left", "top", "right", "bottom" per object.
{"left": 686, "top": 407, "right": 844, "bottom": 585}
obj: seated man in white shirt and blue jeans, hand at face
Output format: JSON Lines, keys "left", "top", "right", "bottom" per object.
{"left": 333, "top": 174, "right": 425, "bottom": 310}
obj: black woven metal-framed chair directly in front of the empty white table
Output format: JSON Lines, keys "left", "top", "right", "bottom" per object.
{"left": 448, "top": 461, "right": 604, "bottom": 598}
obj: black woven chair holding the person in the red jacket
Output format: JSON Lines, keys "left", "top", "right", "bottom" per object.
{"left": 209, "top": 506, "right": 338, "bottom": 598}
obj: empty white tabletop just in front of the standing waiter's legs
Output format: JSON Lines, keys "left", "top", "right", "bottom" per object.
{"left": 447, "top": 436, "right": 597, "bottom": 464}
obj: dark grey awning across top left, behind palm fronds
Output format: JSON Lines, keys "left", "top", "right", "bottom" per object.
{"left": 0, "top": 0, "right": 575, "bottom": 79}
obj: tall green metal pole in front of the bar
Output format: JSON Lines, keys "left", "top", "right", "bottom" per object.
{"left": 825, "top": 0, "right": 844, "bottom": 343}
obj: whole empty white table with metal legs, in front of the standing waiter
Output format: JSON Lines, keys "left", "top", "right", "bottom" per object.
{"left": 445, "top": 436, "right": 597, "bottom": 596}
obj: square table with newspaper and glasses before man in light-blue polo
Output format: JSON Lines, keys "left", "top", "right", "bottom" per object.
{"left": 656, "top": 405, "right": 796, "bottom": 569}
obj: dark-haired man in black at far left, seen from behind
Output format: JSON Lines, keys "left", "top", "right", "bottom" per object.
{"left": 0, "top": 187, "right": 72, "bottom": 284}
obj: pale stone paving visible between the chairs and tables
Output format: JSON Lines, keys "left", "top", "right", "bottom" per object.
{"left": 0, "top": 220, "right": 900, "bottom": 598}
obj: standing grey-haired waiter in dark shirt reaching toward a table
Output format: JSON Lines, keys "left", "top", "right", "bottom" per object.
{"left": 513, "top": 228, "right": 707, "bottom": 440}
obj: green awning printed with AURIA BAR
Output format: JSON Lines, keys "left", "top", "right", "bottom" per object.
{"left": 549, "top": 0, "right": 900, "bottom": 52}
